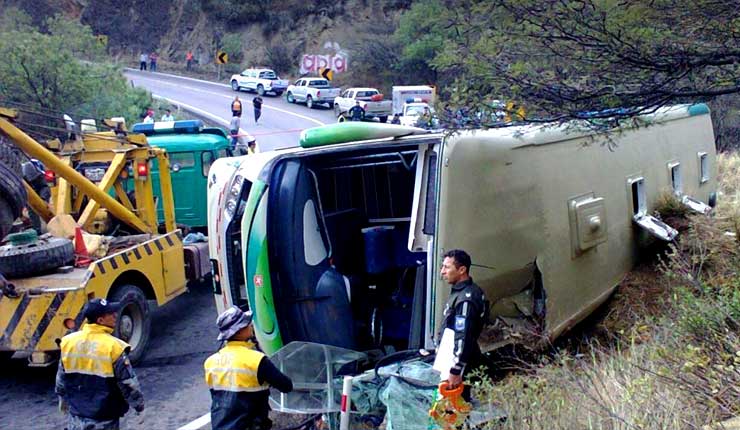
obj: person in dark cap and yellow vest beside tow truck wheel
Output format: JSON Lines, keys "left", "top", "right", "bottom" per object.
{"left": 54, "top": 299, "right": 144, "bottom": 430}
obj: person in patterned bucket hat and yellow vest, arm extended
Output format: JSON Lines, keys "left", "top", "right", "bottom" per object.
{"left": 204, "top": 306, "right": 293, "bottom": 430}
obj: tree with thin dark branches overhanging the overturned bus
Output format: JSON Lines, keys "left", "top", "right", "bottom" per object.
{"left": 404, "top": 0, "right": 740, "bottom": 124}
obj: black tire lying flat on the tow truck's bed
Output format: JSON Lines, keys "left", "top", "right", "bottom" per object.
{"left": 0, "top": 237, "right": 75, "bottom": 278}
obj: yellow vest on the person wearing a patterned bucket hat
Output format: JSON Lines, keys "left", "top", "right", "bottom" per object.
{"left": 204, "top": 341, "right": 269, "bottom": 392}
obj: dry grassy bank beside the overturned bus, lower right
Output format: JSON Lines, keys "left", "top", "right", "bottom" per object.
{"left": 477, "top": 153, "right": 740, "bottom": 430}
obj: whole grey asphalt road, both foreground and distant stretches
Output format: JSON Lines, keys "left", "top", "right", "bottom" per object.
{"left": 0, "top": 72, "right": 335, "bottom": 430}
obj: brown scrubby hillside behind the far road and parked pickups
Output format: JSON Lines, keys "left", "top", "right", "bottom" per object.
{"left": 0, "top": 0, "right": 411, "bottom": 81}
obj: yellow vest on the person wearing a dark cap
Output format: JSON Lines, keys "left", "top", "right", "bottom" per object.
{"left": 61, "top": 324, "right": 129, "bottom": 378}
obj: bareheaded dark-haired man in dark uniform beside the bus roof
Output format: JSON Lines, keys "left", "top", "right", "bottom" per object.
{"left": 440, "top": 249, "right": 488, "bottom": 400}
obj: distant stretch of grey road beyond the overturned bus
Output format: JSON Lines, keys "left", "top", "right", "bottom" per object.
{"left": 126, "top": 70, "right": 336, "bottom": 151}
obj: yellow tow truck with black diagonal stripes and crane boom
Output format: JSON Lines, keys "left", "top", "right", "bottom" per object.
{"left": 0, "top": 108, "right": 210, "bottom": 366}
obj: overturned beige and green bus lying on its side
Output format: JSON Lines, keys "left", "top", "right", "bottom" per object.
{"left": 208, "top": 105, "right": 717, "bottom": 353}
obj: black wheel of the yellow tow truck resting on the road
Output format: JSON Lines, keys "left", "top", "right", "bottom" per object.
{"left": 109, "top": 284, "right": 152, "bottom": 363}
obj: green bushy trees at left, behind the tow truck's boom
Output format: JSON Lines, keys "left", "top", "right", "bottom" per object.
{"left": 0, "top": 8, "right": 158, "bottom": 138}
